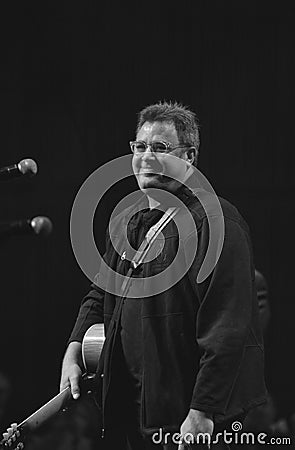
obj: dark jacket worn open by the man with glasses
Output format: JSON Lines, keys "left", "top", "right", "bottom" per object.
{"left": 70, "top": 190, "right": 265, "bottom": 433}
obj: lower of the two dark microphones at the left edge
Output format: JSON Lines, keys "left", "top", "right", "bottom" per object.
{"left": 0, "top": 216, "right": 52, "bottom": 237}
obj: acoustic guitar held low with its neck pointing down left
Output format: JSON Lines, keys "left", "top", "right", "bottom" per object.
{"left": 0, "top": 323, "right": 105, "bottom": 450}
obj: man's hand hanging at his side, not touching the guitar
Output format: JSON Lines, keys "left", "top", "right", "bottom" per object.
{"left": 178, "top": 409, "right": 214, "bottom": 450}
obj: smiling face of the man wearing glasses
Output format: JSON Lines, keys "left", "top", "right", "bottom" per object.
{"left": 132, "top": 122, "right": 192, "bottom": 192}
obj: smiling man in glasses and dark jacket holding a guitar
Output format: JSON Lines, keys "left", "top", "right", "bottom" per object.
{"left": 61, "top": 102, "right": 265, "bottom": 450}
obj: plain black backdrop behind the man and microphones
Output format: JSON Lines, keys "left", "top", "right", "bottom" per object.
{"left": 0, "top": 0, "right": 295, "bottom": 428}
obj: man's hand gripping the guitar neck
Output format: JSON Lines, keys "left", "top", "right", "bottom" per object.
{"left": 60, "top": 342, "right": 82, "bottom": 400}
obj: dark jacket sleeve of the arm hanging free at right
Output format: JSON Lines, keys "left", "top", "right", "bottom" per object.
{"left": 190, "top": 214, "right": 254, "bottom": 414}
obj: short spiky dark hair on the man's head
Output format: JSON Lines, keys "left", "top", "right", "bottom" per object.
{"left": 136, "top": 101, "right": 200, "bottom": 164}
